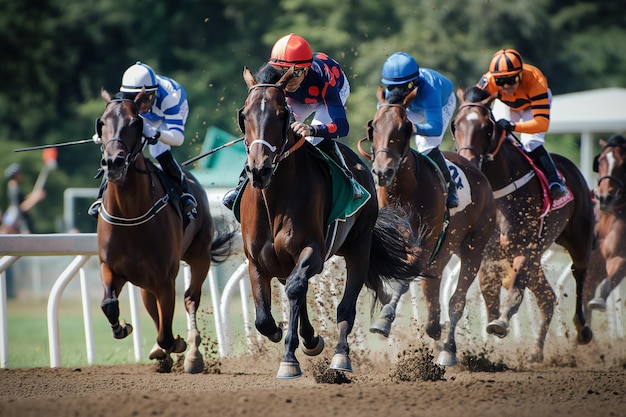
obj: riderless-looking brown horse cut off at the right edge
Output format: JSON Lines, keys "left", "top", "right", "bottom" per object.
{"left": 588, "top": 135, "right": 626, "bottom": 311}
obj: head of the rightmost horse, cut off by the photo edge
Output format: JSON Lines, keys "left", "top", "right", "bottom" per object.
{"left": 593, "top": 135, "right": 626, "bottom": 213}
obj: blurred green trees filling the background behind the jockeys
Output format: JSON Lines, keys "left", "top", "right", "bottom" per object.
{"left": 0, "top": 0, "right": 626, "bottom": 232}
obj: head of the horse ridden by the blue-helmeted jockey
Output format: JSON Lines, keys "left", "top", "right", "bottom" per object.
{"left": 367, "top": 87, "right": 417, "bottom": 187}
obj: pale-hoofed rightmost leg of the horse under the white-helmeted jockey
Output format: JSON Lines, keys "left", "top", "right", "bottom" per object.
{"left": 184, "top": 262, "right": 208, "bottom": 374}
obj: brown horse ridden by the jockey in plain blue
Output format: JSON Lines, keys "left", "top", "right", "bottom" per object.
{"left": 359, "top": 87, "right": 496, "bottom": 365}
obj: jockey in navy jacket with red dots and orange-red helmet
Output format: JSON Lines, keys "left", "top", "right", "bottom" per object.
{"left": 223, "top": 33, "right": 362, "bottom": 209}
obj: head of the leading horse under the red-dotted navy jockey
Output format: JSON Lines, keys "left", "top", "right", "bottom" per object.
{"left": 238, "top": 65, "right": 304, "bottom": 189}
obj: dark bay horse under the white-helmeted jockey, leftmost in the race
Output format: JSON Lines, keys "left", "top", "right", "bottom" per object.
{"left": 97, "top": 90, "right": 234, "bottom": 373}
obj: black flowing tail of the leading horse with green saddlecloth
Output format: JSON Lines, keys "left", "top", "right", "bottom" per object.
{"left": 366, "top": 206, "right": 429, "bottom": 298}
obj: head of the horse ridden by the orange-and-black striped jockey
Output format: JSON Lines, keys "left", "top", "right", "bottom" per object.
{"left": 451, "top": 87, "right": 504, "bottom": 168}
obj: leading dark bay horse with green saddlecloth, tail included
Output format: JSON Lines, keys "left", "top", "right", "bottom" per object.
{"left": 239, "top": 67, "right": 427, "bottom": 378}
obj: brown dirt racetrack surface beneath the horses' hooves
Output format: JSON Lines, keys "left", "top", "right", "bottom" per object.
{"left": 0, "top": 346, "right": 626, "bottom": 417}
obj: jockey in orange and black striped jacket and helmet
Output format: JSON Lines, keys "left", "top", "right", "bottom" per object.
{"left": 477, "top": 49, "right": 567, "bottom": 200}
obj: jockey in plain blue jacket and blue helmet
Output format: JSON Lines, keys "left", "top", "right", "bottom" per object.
{"left": 381, "top": 52, "right": 459, "bottom": 208}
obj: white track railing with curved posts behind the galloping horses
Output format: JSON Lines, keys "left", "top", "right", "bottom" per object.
{"left": 0, "top": 234, "right": 625, "bottom": 368}
